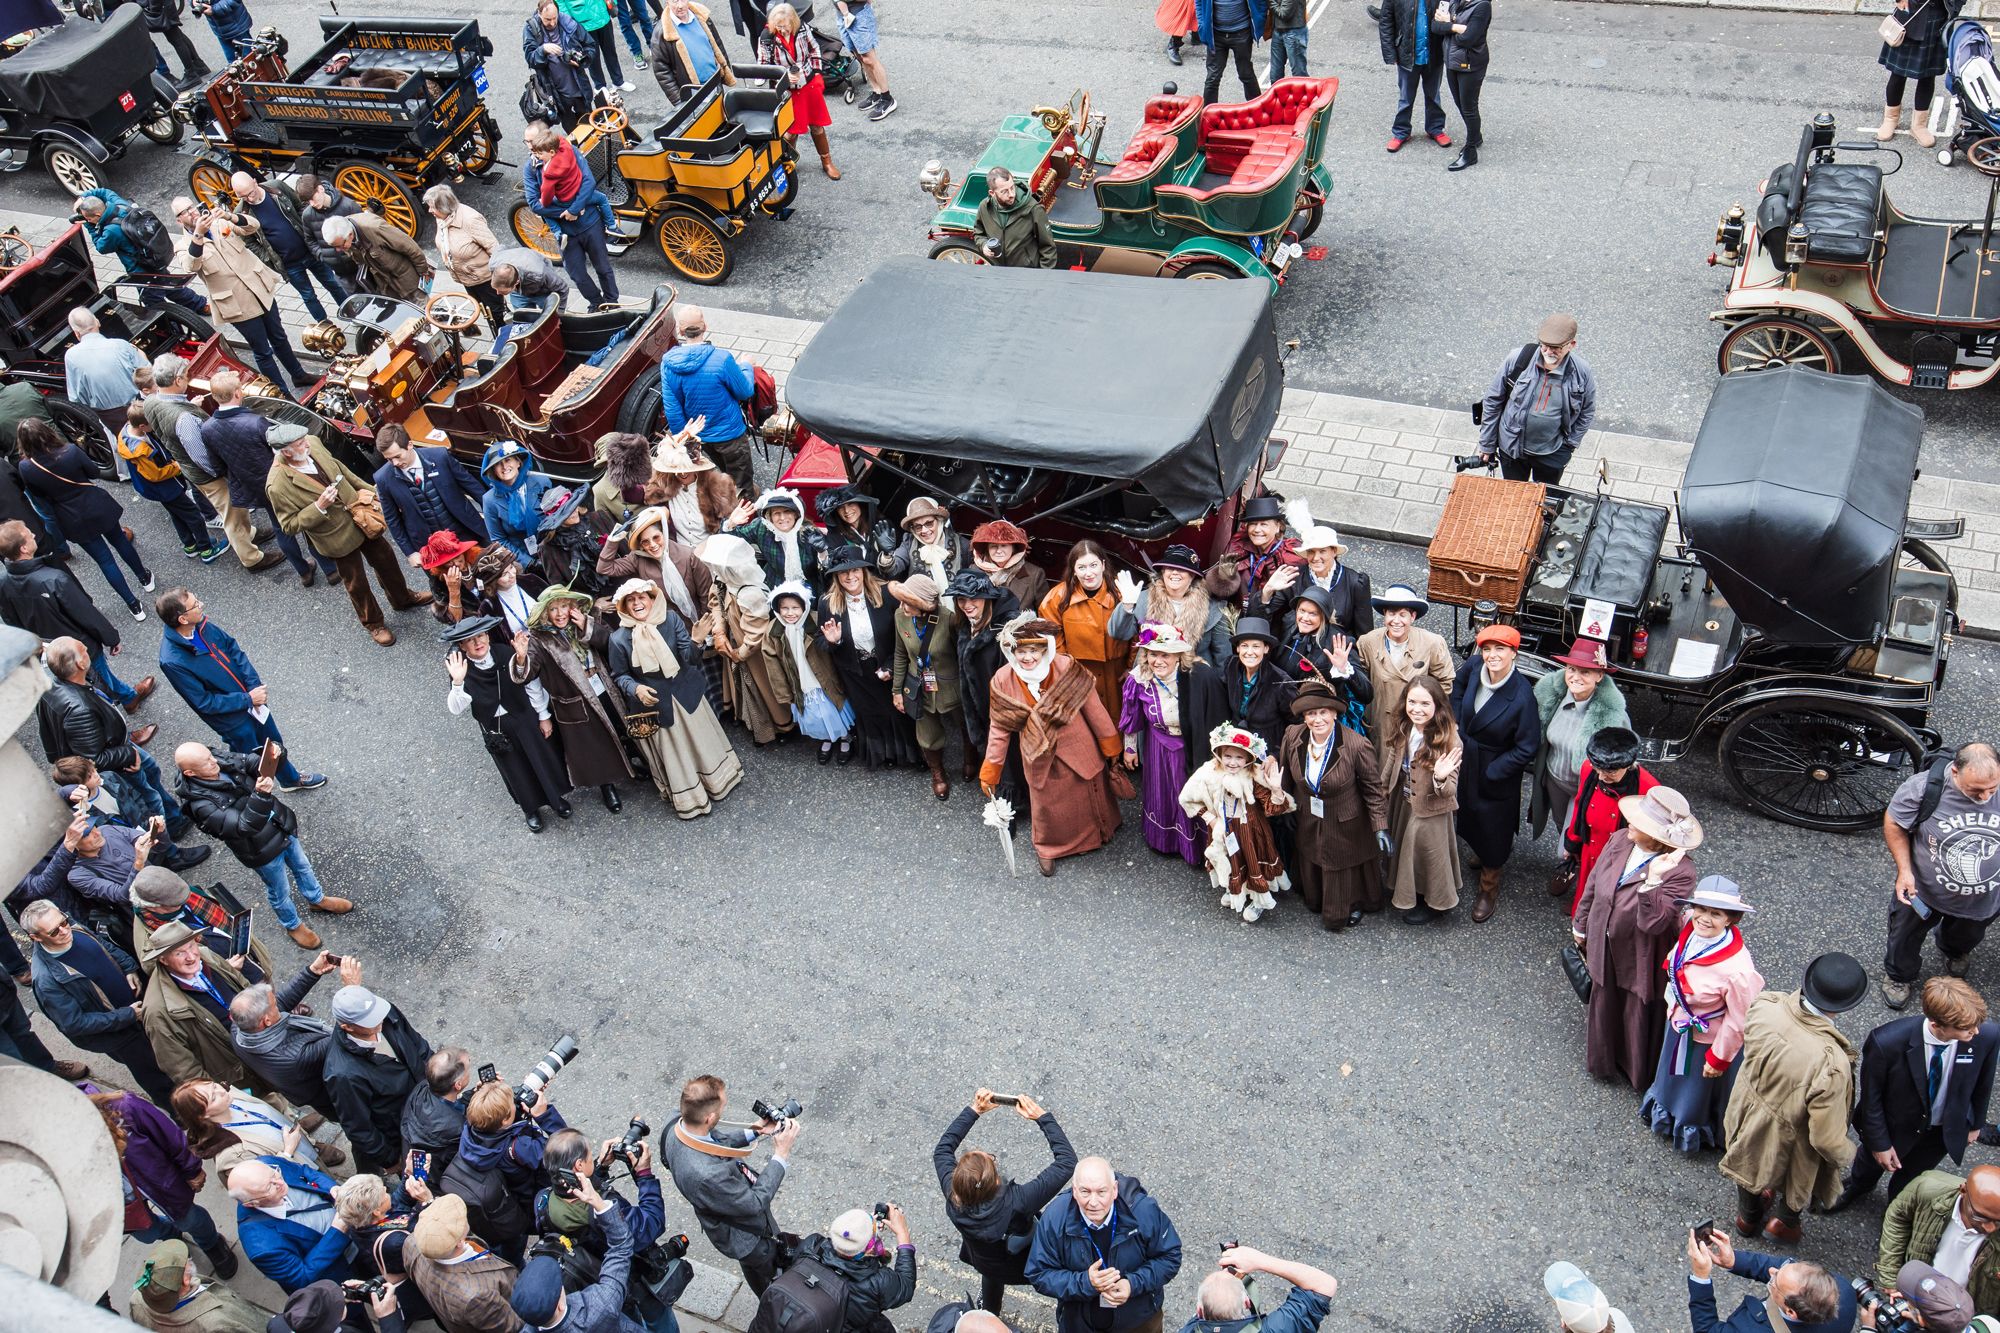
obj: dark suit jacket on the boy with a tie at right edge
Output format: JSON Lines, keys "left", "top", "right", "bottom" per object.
{"left": 1854, "top": 1015, "right": 2000, "bottom": 1161}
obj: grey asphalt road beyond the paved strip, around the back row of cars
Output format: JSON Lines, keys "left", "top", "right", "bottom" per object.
{"left": 10, "top": 0, "right": 2000, "bottom": 480}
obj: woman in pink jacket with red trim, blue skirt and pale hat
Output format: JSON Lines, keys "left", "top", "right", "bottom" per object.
{"left": 1638, "top": 875, "right": 1764, "bottom": 1153}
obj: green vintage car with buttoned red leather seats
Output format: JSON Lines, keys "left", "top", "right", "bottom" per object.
{"left": 918, "top": 78, "right": 1340, "bottom": 286}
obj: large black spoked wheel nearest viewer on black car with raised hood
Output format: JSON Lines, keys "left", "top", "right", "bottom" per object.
{"left": 1720, "top": 699, "right": 1924, "bottom": 831}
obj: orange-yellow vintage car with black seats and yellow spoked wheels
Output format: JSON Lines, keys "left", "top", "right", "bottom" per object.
{"left": 510, "top": 64, "right": 798, "bottom": 286}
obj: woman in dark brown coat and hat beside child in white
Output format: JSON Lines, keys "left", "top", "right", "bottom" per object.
{"left": 1278, "top": 681, "right": 1390, "bottom": 931}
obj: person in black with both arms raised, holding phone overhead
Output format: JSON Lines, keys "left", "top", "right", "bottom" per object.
{"left": 930, "top": 1087, "right": 1076, "bottom": 1315}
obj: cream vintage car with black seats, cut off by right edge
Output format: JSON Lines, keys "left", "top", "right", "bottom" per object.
{"left": 1708, "top": 112, "right": 2000, "bottom": 388}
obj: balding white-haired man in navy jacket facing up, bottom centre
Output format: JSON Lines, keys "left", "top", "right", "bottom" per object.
{"left": 1028, "top": 1157, "right": 1180, "bottom": 1333}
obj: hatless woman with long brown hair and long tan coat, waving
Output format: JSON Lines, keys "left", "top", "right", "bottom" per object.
{"left": 1378, "top": 677, "right": 1466, "bottom": 925}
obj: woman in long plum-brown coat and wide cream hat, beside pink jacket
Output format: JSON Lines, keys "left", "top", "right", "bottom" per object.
{"left": 1570, "top": 787, "right": 1702, "bottom": 1093}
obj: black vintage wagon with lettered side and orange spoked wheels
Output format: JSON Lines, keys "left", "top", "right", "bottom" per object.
{"left": 180, "top": 16, "right": 500, "bottom": 236}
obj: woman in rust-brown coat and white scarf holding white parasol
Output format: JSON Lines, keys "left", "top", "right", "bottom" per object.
{"left": 980, "top": 614, "right": 1122, "bottom": 875}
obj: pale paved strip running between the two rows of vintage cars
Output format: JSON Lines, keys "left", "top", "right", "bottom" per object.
{"left": 11, "top": 204, "right": 2000, "bottom": 638}
